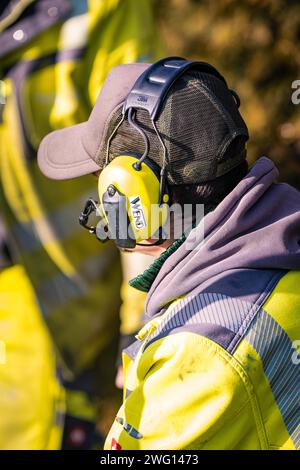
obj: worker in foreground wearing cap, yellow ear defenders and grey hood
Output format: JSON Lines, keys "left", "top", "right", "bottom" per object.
{"left": 38, "top": 57, "right": 300, "bottom": 450}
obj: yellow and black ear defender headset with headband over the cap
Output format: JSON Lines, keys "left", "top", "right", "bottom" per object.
{"left": 79, "top": 57, "right": 230, "bottom": 249}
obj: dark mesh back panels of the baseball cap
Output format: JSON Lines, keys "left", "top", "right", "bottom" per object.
{"left": 97, "top": 71, "right": 248, "bottom": 185}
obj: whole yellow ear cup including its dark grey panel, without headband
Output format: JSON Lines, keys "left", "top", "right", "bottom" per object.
{"left": 98, "top": 155, "right": 169, "bottom": 249}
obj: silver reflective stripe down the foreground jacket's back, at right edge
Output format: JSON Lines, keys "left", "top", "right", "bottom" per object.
{"left": 244, "top": 310, "right": 300, "bottom": 449}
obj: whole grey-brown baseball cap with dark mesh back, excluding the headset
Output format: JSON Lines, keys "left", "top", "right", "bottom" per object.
{"left": 38, "top": 59, "right": 248, "bottom": 185}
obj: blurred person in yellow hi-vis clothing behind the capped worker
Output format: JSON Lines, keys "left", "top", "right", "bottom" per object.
{"left": 0, "top": 0, "right": 159, "bottom": 449}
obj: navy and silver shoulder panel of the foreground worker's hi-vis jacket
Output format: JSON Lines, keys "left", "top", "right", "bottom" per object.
{"left": 145, "top": 270, "right": 286, "bottom": 354}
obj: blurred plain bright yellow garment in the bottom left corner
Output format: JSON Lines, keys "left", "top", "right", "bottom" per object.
{"left": 0, "top": 265, "right": 65, "bottom": 450}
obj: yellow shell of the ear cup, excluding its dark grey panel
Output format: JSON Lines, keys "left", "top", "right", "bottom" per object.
{"left": 98, "top": 155, "right": 169, "bottom": 243}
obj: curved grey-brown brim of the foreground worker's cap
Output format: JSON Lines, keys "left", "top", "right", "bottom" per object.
{"left": 38, "top": 122, "right": 100, "bottom": 180}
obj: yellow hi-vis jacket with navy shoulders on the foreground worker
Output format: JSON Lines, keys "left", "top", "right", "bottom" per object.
{"left": 105, "top": 269, "right": 300, "bottom": 449}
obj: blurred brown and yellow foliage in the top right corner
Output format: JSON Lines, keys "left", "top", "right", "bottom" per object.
{"left": 156, "top": 0, "right": 300, "bottom": 189}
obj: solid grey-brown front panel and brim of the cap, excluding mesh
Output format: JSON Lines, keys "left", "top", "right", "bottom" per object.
{"left": 38, "top": 63, "right": 149, "bottom": 180}
